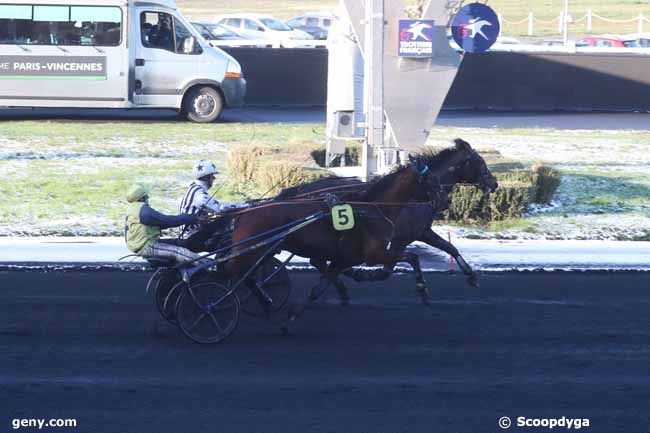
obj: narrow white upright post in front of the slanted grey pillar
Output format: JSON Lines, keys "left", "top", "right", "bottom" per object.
{"left": 362, "top": 0, "right": 384, "bottom": 180}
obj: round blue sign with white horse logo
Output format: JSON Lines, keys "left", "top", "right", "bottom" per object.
{"left": 451, "top": 3, "right": 501, "bottom": 53}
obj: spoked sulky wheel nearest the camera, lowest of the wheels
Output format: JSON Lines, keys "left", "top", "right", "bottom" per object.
{"left": 176, "top": 281, "right": 239, "bottom": 344}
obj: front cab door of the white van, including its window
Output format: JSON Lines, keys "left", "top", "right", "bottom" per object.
{"left": 134, "top": 8, "right": 202, "bottom": 108}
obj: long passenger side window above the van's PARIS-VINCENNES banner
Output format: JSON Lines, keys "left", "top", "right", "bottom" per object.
{"left": 0, "top": 5, "right": 122, "bottom": 47}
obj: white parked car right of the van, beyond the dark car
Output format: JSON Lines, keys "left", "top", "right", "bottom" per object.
{"left": 215, "top": 14, "right": 314, "bottom": 48}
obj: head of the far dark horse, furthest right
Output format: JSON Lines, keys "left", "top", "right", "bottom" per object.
{"left": 448, "top": 138, "right": 499, "bottom": 193}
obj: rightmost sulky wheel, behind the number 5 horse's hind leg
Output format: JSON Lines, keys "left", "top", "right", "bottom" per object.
{"left": 239, "top": 257, "right": 291, "bottom": 316}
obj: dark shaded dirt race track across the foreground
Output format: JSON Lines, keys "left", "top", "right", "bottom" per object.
{"left": 0, "top": 272, "right": 650, "bottom": 433}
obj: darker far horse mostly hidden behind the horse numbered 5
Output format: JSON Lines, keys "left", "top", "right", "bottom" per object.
{"left": 277, "top": 139, "right": 498, "bottom": 296}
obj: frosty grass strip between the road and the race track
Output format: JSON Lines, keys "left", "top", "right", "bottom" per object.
{"left": 0, "top": 121, "right": 650, "bottom": 240}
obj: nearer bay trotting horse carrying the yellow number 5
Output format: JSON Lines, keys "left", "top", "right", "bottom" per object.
{"left": 223, "top": 148, "right": 440, "bottom": 314}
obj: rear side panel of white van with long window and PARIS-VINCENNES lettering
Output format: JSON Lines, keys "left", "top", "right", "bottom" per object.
{"left": 0, "top": 3, "right": 128, "bottom": 107}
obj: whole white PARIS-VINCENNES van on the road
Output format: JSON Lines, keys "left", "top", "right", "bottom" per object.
{"left": 0, "top": 0, "right": 246, "bottom": 122}
